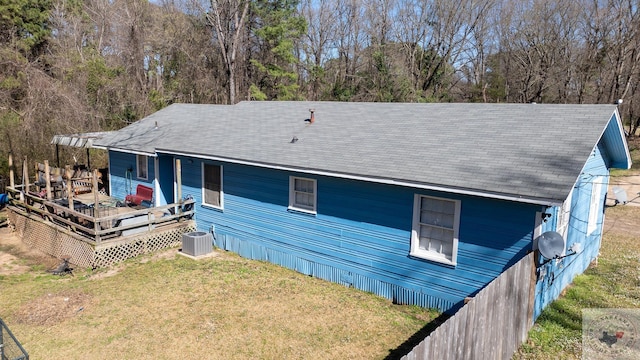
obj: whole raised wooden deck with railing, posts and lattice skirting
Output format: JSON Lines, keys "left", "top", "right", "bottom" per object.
{"left": 1, "top": 154, "right": 196, "bottom": 268}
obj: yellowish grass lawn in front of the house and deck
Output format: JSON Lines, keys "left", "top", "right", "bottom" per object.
{"left": 0, "top": 225, "right": 439, "bottom": 359}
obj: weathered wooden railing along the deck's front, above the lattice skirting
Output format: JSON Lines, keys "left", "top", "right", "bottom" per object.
{"left": 7, "top": 185, "right": 195, "bottom": 244}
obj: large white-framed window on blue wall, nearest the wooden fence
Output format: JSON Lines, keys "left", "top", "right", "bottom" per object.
{"left": 410, "top": 194, "right": 460, "bottom": 265}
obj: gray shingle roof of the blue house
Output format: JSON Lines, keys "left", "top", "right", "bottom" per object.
{"left": 97, "top": 102, "right": 615, "bottom": 203}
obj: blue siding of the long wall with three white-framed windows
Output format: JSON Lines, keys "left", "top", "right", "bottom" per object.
{"left": 168, "top": 158, "right": 540, "bottom": 310}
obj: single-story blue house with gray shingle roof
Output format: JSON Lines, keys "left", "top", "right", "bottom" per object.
{"left": 97, "top": 102, "right": 631, "bottom": 316}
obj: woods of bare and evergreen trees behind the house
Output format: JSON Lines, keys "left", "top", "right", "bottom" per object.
{"left": 0, "top": 0, "right": 640, "bottom": 176}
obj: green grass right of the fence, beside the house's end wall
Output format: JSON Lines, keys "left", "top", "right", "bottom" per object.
{"left": 514, "top": 206, "right": 640, "bottom": 359}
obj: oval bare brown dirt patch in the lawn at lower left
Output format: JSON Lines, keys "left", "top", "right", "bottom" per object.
{"left": 14, "top": 291, "right": 91, "bottom": 326}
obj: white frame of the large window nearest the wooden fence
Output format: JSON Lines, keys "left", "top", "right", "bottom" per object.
{"left": 409, "top": 194, "right": 461, "bottom": 266}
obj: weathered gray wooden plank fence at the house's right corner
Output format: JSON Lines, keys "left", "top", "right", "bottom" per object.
{"left": 402, "top": 253, "right": 535, "bottom": 360}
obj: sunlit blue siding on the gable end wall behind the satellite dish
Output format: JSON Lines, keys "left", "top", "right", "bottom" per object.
{"left": 534, "top": 143, "right": 609, "bottom": 318}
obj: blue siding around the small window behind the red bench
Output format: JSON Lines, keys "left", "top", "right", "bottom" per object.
{"left": 109, "top": 151, "right": 155, "bottom": 200}
